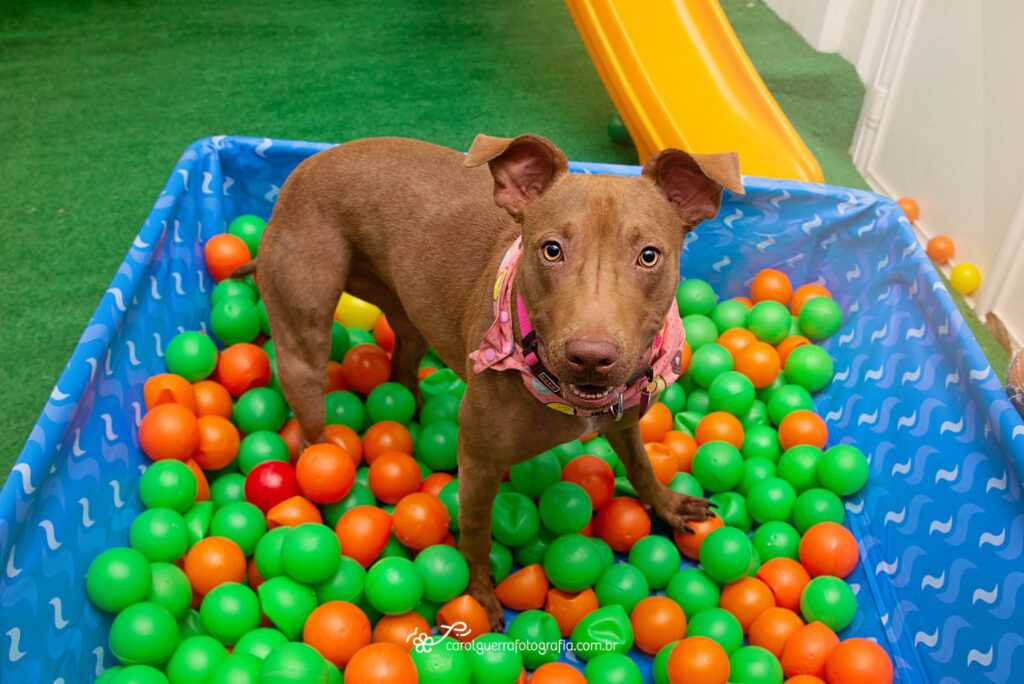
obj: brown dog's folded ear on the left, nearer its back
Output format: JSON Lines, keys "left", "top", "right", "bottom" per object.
{"left": 463, "top": 133, "right": 568, "bottom": 218}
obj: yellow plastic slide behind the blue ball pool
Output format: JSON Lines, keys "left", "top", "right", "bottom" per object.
{"left": 565, "top": 0, "right": 822, "bottom": 182}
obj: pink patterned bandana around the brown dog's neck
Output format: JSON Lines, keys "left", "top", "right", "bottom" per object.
{"left": 469, "top": 238, "right": 685, "bottom": 420}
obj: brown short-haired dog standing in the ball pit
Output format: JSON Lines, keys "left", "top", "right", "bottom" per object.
{"left": 247, "top": 135, "right": 742, "bottom": 629}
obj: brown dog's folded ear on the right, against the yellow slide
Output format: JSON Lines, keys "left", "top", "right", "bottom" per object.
{"left": 643, "top": 148, "right": 743, "bottom": 230}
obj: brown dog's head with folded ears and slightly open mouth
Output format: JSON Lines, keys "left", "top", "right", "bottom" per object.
{"left": 465, "top": 135, "right": 743, "bottom": 409}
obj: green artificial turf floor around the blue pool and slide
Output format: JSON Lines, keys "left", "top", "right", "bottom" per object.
{"left": 0, "top": 0, "right": 1005, "bottom": 481}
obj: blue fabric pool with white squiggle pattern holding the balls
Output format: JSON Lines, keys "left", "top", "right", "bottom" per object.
{"left": 0, "top": 136, "right": 1024, "bottom": 684}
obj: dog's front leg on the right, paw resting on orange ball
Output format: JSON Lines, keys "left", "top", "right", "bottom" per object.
{"left": 604, "top": 423, "right": 714, "bottom": 532}
